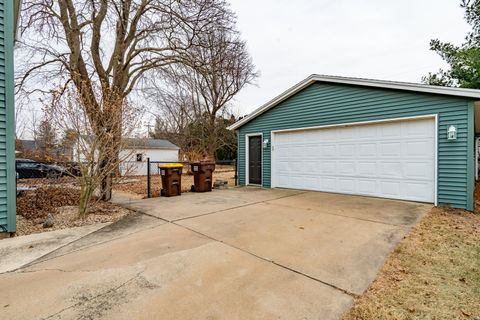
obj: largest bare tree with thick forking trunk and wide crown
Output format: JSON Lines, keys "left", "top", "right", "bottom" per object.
{"left": 17, "top": 0, "right": 232, "bottom": 199}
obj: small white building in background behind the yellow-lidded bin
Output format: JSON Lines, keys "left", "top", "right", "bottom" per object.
{"left": 120, "top": 138, "right": 180, "bottom": 176}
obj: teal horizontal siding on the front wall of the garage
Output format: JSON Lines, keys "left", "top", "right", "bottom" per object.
{"left": 238, "top": 82, "right": 474, "bottom": 210}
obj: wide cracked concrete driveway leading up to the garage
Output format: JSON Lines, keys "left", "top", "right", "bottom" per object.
{"left": 0, "top": 188, "right": 431, "bottom": 319}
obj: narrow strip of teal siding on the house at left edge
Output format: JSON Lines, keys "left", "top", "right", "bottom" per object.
{"left": 0, "top": 0, "right": 16, "bottom": 232}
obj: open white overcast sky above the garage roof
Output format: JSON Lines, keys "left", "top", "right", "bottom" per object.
{"left": 230, "top": 0, "right": 470, "bottom": 115}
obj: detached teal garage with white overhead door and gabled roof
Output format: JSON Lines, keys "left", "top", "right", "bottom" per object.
{"left": 230, "top": 75, "right": 480, "bottom": 210}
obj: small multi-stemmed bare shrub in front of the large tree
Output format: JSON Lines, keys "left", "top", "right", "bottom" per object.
{"left": 46, "top": 84, "right": 140, "bottom": 217}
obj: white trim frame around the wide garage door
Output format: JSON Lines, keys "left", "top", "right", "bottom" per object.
{"left": 270, "top": 114, "right": 438, "bottom": 205}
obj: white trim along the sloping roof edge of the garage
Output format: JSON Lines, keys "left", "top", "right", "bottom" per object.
{"left": 228, "top": 74, "right": 480, "bottom": 130}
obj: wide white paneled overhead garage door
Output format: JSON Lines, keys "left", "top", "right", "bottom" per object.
{"left": 272, "top": 118, "right": 435, "bottom": 202}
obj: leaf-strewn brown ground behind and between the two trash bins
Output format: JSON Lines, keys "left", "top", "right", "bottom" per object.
{"left": 113, "top": 166, "right": 235, "bottom": 198}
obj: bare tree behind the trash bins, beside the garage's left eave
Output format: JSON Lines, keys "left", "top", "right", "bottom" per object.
{"left": 149, "top": 19, "right": 258, "bottom": 158}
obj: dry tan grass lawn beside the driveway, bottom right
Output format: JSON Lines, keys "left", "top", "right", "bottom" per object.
{"left": 343, "top": 206, "right": 480, "bottom": 320}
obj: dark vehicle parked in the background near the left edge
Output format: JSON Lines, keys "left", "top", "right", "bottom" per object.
{"left": 15, "top": 159, "right": 67, "bottom": 179}
